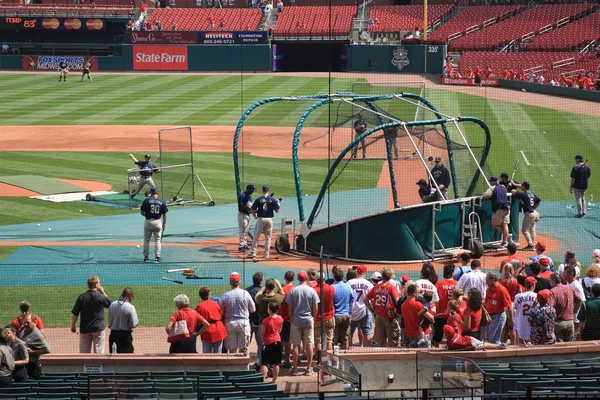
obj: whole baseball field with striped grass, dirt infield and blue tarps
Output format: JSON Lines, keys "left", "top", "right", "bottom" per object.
{"left": 0, "top": 73, "right": 600, "bottom": 350}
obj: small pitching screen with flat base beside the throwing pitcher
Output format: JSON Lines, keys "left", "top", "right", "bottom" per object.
{"left": 88, "top": 126, "right": 215, "bottom": 209}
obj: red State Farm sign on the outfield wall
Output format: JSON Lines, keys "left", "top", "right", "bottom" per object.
{"left": 133, "top": 46, "right": 188, "bottom": 71}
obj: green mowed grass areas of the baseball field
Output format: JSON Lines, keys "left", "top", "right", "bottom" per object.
{"left": 0, "top": 74, "right": 600, "bottom": 327}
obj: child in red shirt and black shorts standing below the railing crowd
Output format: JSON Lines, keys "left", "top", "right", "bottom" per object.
{"left": 260, "top": 302, "right": 283, "bottom": 383}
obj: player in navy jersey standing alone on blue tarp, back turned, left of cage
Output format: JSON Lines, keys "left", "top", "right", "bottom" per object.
{"left": 140, "top": 187, "right": 169, "bottom": 262}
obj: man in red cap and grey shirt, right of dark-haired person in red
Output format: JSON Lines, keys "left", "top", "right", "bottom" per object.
{"left": 219, "top": 272, "right": 255, "bottom": 353}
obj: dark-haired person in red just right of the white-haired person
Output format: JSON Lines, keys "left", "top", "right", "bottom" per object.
{"left": 196, "top": 286, "right": 227, "bottom": 354}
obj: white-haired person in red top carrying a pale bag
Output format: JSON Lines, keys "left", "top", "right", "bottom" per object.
{"left": 166, "top": 294, "right": 209, "bottom": 354}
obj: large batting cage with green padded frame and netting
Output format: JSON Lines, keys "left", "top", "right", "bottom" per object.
{"left": 233, "top": 92, "right": 519, "bottom": 262}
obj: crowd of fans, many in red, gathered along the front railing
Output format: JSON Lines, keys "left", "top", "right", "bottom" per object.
{"left": 0, "top": 247, "right": 600, "bottom": 385}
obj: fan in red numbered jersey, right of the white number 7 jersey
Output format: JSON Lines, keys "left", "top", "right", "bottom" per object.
{"left": 365, "top": 267, "right": 398, "bottom": 347}
